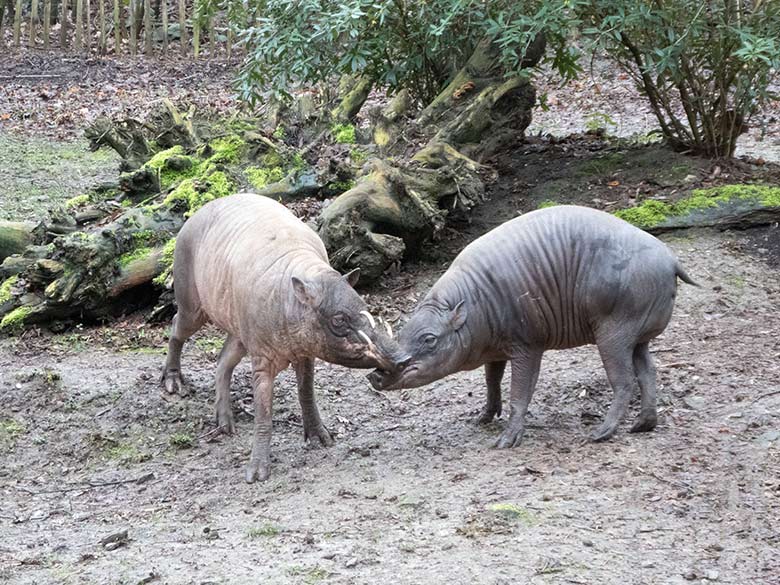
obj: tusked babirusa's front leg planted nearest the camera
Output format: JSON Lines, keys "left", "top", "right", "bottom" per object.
{"left": 246, "top": 357, "right": 279, "bottom": 483}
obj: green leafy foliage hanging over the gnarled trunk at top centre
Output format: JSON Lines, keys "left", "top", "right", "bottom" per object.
{"left": 231, "top": 0, "right": 579, "bottom": 102}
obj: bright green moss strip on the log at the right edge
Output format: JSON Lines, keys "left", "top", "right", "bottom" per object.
{"left": 615, "top": 185, "right": 780, "bottom": 229}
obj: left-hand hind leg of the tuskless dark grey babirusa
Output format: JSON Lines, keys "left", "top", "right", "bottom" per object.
{"left": 590, "top": 336, "right": 637, "bottom": 441}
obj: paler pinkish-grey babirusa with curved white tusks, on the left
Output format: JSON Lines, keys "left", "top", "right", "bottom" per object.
{"left": 163, "top": 193, "right": 396, "bottom": 482}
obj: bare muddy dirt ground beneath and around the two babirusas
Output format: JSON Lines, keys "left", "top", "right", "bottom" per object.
{"left": 0, "top": 54, "right": 780, "bottom": 585}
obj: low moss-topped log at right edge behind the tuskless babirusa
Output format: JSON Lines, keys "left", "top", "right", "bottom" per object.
{"left": 615, "top": 184, "right": 780, "bottom": 232}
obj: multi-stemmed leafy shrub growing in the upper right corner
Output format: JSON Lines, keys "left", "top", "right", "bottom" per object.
{"left": 578, "top": 0, "right": 780, "bottom": 156}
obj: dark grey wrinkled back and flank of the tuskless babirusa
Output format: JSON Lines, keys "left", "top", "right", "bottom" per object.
{"left": 450, "top": 206, "right": 677, "bottom": 349}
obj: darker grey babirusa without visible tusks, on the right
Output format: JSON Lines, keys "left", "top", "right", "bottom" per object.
{"left": 369, "top": 206, "right": 695, "bottom": 448}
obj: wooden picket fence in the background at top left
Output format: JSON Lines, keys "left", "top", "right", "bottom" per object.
{"left": 0, "top": 0, "right": 241, "bottom": 59}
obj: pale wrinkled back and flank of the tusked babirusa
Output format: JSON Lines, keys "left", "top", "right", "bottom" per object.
{"left": 179, "top": 193, "right": 333, "bottom": 349}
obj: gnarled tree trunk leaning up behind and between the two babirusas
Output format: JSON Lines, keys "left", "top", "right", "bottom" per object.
{"left": 319, "top": 37, "right": 544, "bottom": 282}
